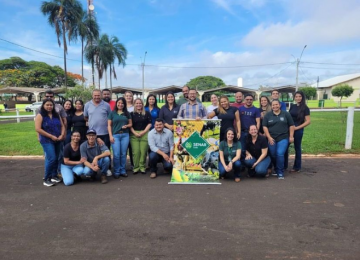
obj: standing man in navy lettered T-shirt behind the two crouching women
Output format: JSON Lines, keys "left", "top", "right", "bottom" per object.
{"left": 239, "top": 94, "right": 261, "bottom": 161}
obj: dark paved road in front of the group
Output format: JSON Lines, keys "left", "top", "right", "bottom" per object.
{"left": 0, "top": 158, "right": 360, "bottom": 260}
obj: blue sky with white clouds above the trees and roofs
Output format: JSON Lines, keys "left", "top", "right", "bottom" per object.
{"left": 0, "top": 0, "right": 360, "bottom": 89}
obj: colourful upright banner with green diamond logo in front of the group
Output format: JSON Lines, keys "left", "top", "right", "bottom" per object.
{"left": 169, "top": 119, "right": 221, "bottom": 184}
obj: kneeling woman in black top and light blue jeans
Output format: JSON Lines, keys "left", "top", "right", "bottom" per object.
{"left": 61, "top": 131, "right": 86, "bottom": 186}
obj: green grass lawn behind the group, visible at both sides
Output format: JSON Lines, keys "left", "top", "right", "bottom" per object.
{"left": 0, "top": 112, "right": 360, "bottom": 155}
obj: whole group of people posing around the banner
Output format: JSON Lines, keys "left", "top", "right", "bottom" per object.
{"left": 35, "top": 86, "right": 310, "bottom": 186}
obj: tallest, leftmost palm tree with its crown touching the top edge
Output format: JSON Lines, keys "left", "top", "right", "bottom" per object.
{"left": 40, "top": 0, "right": 83, "bottom": 88}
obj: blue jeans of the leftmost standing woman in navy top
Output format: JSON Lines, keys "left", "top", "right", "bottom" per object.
{"left": 41, "top": 142, "right": 63, "bottom": 180}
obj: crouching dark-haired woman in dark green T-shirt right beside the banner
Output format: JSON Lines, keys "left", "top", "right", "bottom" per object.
{"left": 219, "top": 128, "right": 241, "bottom": 182}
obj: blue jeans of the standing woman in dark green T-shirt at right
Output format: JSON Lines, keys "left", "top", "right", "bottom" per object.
{"left": 269, "top": 138, "right": 289, "bottom": 177}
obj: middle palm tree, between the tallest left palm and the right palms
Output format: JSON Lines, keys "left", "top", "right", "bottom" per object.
{"left": 76, "top": 11, "right": 100, "bottom": 85}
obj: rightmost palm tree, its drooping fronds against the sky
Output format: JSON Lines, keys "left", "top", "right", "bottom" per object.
{"left": 109, "top": 36, "right": 127, "bottom": 91}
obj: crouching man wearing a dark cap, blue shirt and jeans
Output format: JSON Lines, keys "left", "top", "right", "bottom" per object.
{"left": 80, "top": 128, "right": 110, "bottom": 184}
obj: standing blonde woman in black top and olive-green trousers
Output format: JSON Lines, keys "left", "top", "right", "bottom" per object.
{"left": 130, "top": 98, "right": 151, "bottom": 174}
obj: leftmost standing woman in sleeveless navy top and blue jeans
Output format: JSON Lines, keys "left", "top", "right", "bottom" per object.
{"left": 35, "top": 99, "right": 65, "bottom": 187}
